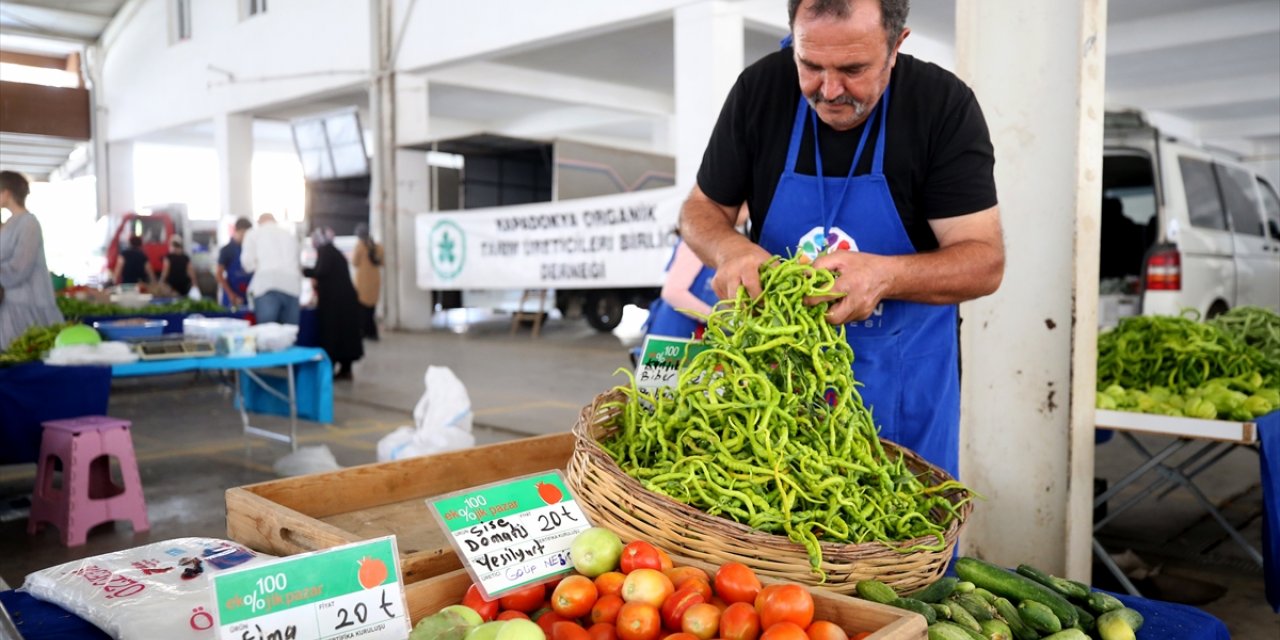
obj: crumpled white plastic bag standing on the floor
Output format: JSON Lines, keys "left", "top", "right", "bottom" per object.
{"left": 378, "top": 366, "right": 476, "bottom": 462}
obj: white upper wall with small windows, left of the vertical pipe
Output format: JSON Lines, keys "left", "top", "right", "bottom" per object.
{"left": 100, "top": 0, "right": 369, "bottom": 141}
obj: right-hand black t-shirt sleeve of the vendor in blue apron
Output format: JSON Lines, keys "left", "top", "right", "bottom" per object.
{"left": 915, "top": 81, "right": 997, "bottom": 220}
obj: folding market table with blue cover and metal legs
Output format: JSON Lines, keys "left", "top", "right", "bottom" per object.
{"left": 111, "top": 347, "right": 333, "bottom": 449}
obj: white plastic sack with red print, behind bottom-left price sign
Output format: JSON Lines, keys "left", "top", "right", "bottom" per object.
{"left": 22, "top": 538, "right": 273, "bottom": 640}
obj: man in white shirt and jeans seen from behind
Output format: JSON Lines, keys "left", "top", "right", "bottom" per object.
{"left": 241, "top": 214, "right": 300, "bottom": 325}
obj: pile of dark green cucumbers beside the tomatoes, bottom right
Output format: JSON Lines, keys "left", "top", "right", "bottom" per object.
{"left": 858, "top": 557, "right": 1143, "bottom": 640}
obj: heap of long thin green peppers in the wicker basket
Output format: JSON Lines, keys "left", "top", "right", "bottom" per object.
{"left": 602, "top": 257, "right": 970, "bottom": 573}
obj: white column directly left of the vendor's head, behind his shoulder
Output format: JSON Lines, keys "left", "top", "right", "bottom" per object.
{"left": 671, "top": 0, "right": 744, "bottom": 188}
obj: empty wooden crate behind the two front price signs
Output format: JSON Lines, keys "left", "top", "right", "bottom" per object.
{"left": 227, "top": 434, "right": 573, "bottom": 585}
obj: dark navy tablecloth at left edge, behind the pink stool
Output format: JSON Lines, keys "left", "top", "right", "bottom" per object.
{"left": 0, "top": 362, "right": 111, "bottom": 465}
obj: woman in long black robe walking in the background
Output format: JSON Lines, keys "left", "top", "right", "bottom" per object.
{"left": 302, "top": 229, "right": 365, "bottom": 380}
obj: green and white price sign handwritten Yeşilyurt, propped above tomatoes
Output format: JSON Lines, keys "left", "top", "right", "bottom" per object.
{"left": 426, "top": 471, "right": 591, "bottom": 600}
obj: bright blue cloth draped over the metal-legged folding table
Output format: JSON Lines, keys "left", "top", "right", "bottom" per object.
{"left": 111, "top": 347, "right": 333, "bottom": 424}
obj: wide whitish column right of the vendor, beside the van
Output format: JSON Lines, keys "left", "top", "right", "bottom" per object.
{"left": 956, "top": 0, "right": 1106, "bottom": 580}
